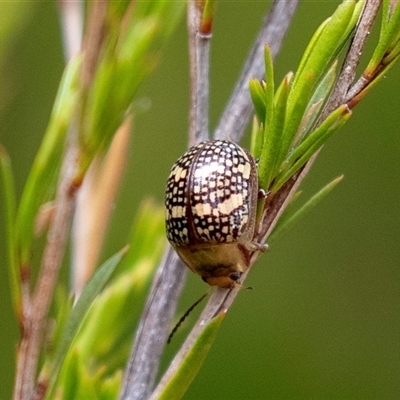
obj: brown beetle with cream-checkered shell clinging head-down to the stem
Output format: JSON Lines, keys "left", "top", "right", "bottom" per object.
{"left": 165, "top": 140, "right": 266, "bottom": 288}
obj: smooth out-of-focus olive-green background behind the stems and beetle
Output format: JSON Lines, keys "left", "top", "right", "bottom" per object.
{"left": 0, "top": 1, "right": 400, "bottom": 399}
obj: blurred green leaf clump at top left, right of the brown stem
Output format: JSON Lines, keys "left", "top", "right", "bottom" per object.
{"left": 79, "top": 1, "right": 185, "bottom": 176}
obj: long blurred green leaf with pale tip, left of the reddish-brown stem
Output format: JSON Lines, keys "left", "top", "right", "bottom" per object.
{"left": 16, "top": 57, "right": 81, "bottom": 266}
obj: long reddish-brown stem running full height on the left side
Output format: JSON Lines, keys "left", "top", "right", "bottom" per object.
{"left": 13, "top": 1, "right": 107, "bottom": 400}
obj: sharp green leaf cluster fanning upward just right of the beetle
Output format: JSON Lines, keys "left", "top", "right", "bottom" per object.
{"left": 250, "top": 1, "right": 363, "bottom": 193}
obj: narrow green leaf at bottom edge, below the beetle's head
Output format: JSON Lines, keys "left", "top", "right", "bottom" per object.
{"left": 159, "top": 312, "right": 225, "bottom": 400}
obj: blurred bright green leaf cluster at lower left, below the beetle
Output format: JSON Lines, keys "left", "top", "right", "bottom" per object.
{"left": 45, "top": 200, "right": 165, "bottom": 399}
